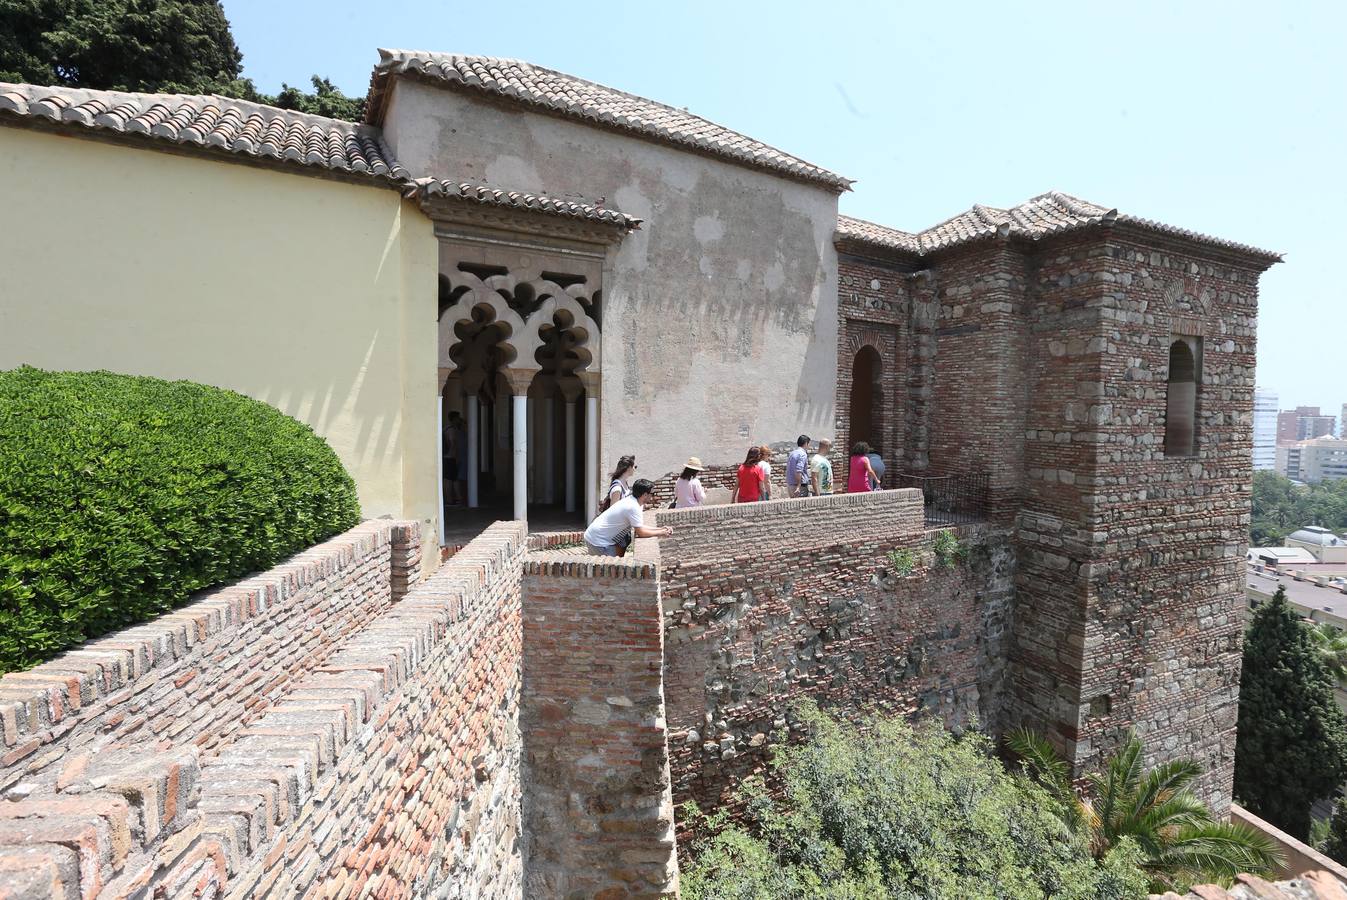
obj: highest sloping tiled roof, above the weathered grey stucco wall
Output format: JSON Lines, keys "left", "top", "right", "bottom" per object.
{"left": 366, "top": 49, "right": 851, "bottom": 191}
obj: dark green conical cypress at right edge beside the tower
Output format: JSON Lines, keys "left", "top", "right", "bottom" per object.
{"left": 1235, "top": 586, "right": 1347, "bottom": 841}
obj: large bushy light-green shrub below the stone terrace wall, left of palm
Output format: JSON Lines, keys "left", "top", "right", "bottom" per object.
{"left": 682, "top": 706, "right": 1146, "bottom": 900}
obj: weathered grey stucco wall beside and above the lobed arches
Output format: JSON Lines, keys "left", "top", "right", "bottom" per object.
{"left": 384, "top": 79, "right": 836, "bottom": 477}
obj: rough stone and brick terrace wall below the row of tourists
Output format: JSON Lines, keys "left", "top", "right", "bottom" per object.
{"left": 659, "top": 489, "right": 1014, "bottom": 808}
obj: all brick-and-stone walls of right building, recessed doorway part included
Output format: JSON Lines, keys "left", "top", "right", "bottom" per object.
{"left": 836, "top": 225, "right": 1266, "bottom": 810}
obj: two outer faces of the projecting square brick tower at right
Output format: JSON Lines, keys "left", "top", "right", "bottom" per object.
{"left": 1013, "top": 232, "right": 1261, "bottom": 812}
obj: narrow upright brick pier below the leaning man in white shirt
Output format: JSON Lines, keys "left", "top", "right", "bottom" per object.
{"left": 520, "top": 542, "right": 678, "bottom": 900}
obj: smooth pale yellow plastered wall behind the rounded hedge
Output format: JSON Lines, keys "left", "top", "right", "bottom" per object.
{"left": 0, "top": 127, "right": 438, "bottom": 563}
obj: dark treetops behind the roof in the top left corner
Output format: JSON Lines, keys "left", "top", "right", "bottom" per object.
{"left": 0, "top": 0, "right": 365, "bottom": 121}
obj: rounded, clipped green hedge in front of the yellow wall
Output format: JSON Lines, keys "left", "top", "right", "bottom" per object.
{"left": 0, "top": 368, "right": 360, "bottom": 672}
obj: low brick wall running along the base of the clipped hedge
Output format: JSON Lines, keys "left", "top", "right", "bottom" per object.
{"left": 0, "top": 520, "right": 420, "bottom": 791}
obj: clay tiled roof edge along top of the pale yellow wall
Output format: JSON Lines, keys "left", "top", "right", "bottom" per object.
{"left": 0, "top": 82, "right": 408, "bottom": 182}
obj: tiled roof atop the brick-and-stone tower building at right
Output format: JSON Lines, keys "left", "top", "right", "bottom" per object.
{"left": 836, "top": 191, "right": 1281, "bottom": 261}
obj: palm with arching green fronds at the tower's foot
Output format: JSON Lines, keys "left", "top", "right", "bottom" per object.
{"left": 1008, "top": 729, "right": 1282, "bottom": 893}
